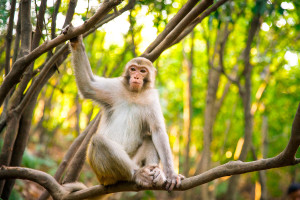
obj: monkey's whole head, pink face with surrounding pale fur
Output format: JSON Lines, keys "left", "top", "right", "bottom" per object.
{"left": 123, "top": 57, "right": 156, "bottom": 92}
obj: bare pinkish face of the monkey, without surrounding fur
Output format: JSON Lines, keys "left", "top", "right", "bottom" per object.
{"left": 128, "top": 65, "right": 149, "bottom": 92}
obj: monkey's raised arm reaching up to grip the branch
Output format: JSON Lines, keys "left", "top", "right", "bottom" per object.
{"left": 70, "top": 36, "right": 119, "bottom": 104}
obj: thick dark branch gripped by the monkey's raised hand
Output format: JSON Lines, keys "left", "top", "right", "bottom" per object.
{"left": 0, "top": 0, "right": 122, "bottom": 105}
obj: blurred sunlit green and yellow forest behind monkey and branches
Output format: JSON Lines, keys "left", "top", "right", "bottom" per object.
{"left": 0, "top": 0, "right": 300, "bottom": 199}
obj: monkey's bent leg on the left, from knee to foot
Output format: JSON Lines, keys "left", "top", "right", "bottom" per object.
{"left": 87, "top": 134, "right": 154, "bottom": 187}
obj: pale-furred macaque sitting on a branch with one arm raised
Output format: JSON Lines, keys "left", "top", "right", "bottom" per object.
{"left": 70, "top": 36, "right": 184, "bottom": 191}
